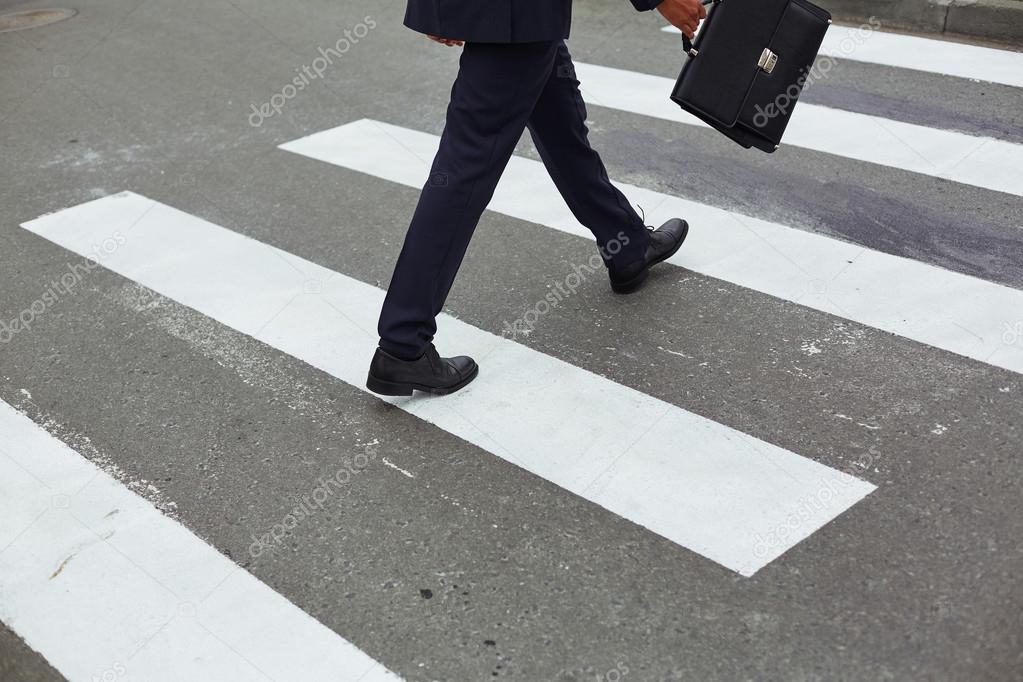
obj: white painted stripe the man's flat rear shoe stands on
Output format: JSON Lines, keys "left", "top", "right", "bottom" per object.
{"left": 25, "top": 192, "right": 874, "bottom": 576}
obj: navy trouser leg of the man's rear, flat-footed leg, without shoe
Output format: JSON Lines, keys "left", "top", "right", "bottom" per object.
{"left": 379, "top": 42, "right": 559, "bottom": 360}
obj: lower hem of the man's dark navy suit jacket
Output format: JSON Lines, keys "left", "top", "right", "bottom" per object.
{"left": 405, "top": 0, "right": 661, "bottom": 43}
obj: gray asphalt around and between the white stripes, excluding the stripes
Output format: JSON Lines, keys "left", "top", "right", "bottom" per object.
{"left": 0, "top": 0, "right": 1023, "bottom": 681}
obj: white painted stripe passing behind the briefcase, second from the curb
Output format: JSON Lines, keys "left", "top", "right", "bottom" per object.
{"left": 576, "top": 62, "right": 1023, "bottom": 196}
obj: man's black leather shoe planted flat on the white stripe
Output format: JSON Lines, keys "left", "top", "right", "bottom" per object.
{"left": 366, "top": 344, "right": 480, "bottom": 396}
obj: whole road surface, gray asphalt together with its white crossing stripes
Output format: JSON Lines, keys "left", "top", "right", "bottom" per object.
{"left": 0, "top": 0, "right": 1023, "bottom": 682}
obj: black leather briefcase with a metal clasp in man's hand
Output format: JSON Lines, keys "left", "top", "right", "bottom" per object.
{"left": 671, "top": 0, "right": 831, "bottom": 152}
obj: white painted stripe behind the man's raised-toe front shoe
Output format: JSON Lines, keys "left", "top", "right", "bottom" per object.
{"left": 281, "top": 120, "right": 1023, "bottom": 372}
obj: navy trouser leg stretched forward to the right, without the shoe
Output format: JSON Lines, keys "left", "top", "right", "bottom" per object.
{"left": 528, "top": 43, "right": 650, "bottom": 265}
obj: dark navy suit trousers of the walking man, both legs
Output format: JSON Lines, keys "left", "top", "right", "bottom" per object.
{"left": 377, "top": 40, "right": 650, "bottom": 359}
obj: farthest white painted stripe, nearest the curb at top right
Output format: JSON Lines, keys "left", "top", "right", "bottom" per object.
{"left": 662, "top": 25, "right": 1023, "bottom": 88}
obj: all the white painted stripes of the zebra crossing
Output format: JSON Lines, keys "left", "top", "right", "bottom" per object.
{"left": 0, "top": 12, "right": 1023, "bottom": 682}
